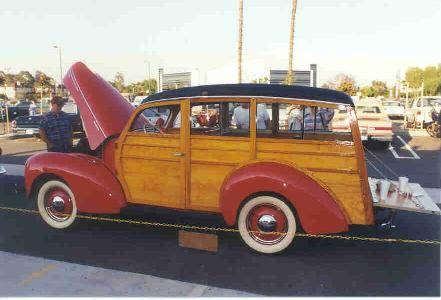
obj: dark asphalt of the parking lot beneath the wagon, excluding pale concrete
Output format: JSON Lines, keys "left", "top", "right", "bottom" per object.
{"left": 0, "top": 128, "right": 441, "bottom": 296}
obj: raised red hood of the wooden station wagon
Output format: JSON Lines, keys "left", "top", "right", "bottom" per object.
{"left": 63, "top": 62, "right": 134, "bottom": 150}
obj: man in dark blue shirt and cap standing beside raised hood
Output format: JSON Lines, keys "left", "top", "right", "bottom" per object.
{"left": 39, "top": 96, "right": 73, "bottom": 153}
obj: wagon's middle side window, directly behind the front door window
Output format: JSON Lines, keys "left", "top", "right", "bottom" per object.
{"left": 190, "top": 102, "right": 250, "bottom": 136}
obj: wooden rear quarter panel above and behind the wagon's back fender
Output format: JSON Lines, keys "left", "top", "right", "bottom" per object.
{"left": 256, "top": 138, "right": 366, "bottom": 224}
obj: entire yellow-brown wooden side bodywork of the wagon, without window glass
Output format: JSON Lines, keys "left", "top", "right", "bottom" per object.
{"left": 115, "top": 98, "right": 373, "bottom": 229}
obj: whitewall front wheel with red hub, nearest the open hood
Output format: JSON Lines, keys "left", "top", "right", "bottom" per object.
{"left": 37, "top": 180, "right": 77, "bottom": 229}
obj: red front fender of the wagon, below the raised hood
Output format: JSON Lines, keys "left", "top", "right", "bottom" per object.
{"left": 25, "top": 152, "right": 127, "bottom": 213}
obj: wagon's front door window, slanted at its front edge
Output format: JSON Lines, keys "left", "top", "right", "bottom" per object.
{"left": 130, "top": 105, "right": 181, "bottom": 134}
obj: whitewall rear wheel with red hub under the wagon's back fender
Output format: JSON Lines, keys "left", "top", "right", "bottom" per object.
{"left": 238, "top": 196, "right": 297, "bottom": 253}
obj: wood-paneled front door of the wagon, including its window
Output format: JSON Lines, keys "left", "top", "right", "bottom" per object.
{"left": 117, "top": 101, "right": 188, "bottom": 208}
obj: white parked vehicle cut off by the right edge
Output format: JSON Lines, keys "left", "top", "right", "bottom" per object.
{"left": 406, "top": 96, "right": 441, "bottom": 127}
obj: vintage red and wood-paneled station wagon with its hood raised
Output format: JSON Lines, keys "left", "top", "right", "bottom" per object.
{"left": 25, "top": 62, "right": 439, "bottom": 253}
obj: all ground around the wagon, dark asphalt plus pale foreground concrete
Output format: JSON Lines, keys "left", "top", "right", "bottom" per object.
{"left": 0, "top": 128, "right": 441, "bottom": 296}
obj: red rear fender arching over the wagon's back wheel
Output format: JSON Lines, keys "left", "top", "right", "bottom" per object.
{"left": 220, "top": 162, "right": 348, "bottom": 234}
